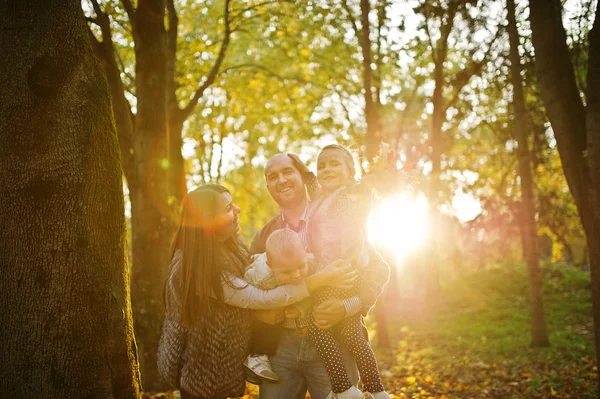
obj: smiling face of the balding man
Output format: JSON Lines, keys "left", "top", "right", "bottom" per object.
{"left": 265, "top": 154, "right": 306, "bottom": 208}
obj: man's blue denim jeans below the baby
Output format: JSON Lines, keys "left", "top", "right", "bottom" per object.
{"left": 260, "top": 328, "right": 358, "bottom": 399}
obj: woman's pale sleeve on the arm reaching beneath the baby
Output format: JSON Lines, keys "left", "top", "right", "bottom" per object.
{"left": 222, "top": 275, "right": 309, "bottom": 309}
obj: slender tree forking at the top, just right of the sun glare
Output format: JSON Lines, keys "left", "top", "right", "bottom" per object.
{"left": 415, "top": 0, "right": 499, "bottom": 302}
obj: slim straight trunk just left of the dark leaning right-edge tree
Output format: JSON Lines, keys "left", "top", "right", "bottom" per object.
{"left": 506, "top": 0, "right": 550, "bottom": 347}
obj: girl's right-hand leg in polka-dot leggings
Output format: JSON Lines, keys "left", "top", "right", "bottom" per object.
{"left": 339, "top": 315, "right": 384, "bottom": 393}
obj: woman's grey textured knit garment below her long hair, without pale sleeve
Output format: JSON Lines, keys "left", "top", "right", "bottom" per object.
{"left": 158, "top": 252, "right": 250, "bottom": 398}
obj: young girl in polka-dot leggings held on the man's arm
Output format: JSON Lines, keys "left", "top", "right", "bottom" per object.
{"left": 308, "top": 144, "right": 390, "bottom": 399}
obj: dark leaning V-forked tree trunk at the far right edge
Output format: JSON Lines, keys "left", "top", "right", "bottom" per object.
{"left": 530, "top": 0, "right": 600, "bottom": 387}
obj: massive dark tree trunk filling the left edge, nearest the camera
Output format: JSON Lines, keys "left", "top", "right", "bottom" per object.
{"left": 0, "top": 0, "right": 140, "bottom": 398}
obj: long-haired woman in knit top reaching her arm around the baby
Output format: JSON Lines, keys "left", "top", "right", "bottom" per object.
{"left": 158, "top": 184, "right": 355, "bottom": 399}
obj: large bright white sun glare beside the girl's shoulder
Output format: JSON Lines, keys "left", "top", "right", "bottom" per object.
{"left": 367, "top": 195, "right": 428, "bottom": 265}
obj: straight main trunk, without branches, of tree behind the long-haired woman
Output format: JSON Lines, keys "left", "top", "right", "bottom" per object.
{"left": 128, "top": 0, "right": 176, "bottom": 391}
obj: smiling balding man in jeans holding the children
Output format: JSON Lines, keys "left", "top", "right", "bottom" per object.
{"left": 250, "top": 154, "right": 389, "bottom": 399}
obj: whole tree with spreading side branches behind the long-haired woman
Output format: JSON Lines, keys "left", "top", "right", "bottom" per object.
{"left": 90, "top": 0, "right": 232, "bottom": 390}
